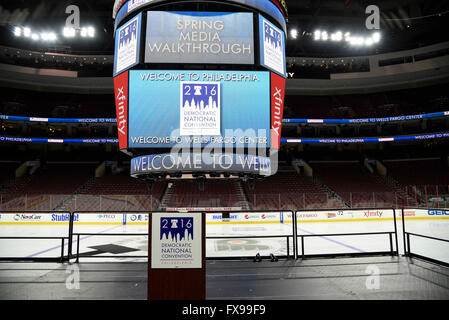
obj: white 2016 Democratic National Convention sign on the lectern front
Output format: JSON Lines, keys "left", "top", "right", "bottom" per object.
{"left": 151, "top": 212, "right": 202, "bottom": 269}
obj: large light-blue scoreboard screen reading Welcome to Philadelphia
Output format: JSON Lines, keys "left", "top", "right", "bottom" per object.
{"left": 129, "top": 70, "right": 271, "bottom": 148}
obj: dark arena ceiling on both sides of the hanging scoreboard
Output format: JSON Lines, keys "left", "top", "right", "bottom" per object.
{"left": 0, "top": 0, "right": 449, "bottom": 56}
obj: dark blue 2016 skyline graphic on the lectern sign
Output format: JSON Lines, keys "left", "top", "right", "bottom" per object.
{"left": 160, "top": 217, "right": 193, "bottom": 242}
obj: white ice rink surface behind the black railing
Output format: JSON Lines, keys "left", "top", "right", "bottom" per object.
{"left": 0, "top": 215, "right": 449, "bottom": 263}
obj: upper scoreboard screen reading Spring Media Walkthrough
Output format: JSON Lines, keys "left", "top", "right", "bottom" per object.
{"left": 145, "top": 11, "right": 254, "bottom": 65}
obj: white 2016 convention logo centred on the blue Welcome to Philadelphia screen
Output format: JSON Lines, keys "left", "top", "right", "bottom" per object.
{"left": 180, "top": 82, "right": 221, "bottom": 136}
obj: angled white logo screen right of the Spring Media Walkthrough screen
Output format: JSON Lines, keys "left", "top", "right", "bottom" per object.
{"left": 259, "top": 15, "right": 287, "bottom": 78}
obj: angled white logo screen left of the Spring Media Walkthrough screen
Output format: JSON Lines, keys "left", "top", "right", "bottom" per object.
{"left": 114, "top": 13, "right": 142, "bottom": 77}
